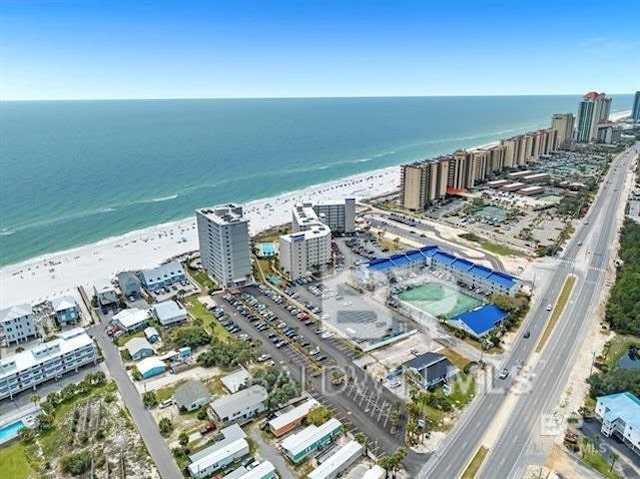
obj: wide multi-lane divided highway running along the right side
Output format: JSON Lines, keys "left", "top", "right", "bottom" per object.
{"left": 418, "top": 147, "right": 637, "bottom": 478}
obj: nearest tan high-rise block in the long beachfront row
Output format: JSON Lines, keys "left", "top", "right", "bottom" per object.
{"left": 401, "top": 157, "right": 449, "bottom": 211}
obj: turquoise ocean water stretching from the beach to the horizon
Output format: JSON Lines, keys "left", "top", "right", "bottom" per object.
{"left": 0, "top": 95, "right": 632, "bottom": 265}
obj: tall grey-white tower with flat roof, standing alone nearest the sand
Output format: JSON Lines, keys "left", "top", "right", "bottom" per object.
{"left": 196, "top": 203, "right": 251, "bottom": 287}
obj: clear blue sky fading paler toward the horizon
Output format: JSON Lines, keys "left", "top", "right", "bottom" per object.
{"left": 0, "top": 0, "right": 640, "bottom": 100}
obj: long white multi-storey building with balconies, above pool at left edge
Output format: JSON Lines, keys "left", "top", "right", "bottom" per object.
{"left": 0, "top": 328, "right": 97, "bottom": 400}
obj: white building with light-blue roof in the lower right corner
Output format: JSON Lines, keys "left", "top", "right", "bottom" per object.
{"left": 596, "top": 392, "right": 640, "bottom": 454}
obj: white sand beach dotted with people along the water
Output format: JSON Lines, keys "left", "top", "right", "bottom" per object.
{"left": 0, "top": 111, "right": 629, "bottom": 308}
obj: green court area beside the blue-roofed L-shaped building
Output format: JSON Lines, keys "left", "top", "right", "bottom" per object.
{"left": 398, "top": 283, "right": 482, "bottom": 318}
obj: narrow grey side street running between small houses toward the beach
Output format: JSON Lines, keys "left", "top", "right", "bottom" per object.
{"left": 87, "top": 324, "right": 183, "bottom": 479}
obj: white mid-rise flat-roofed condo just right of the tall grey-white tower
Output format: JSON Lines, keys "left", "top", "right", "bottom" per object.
{"left": 279, "top": 203, "right": 331, "bottom": 281}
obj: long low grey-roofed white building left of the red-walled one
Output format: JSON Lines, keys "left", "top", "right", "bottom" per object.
{"left": 209, "top": 384, "right": 268, "bottom": 424}
